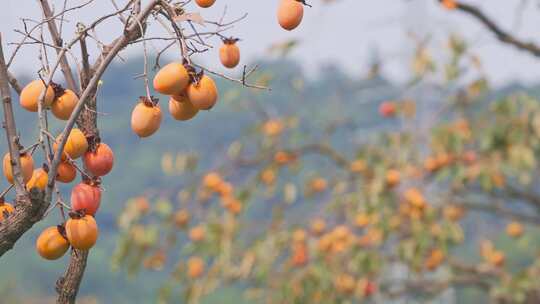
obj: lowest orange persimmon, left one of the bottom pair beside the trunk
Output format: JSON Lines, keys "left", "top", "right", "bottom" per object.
{"left": 36, "top": 226, "right": 69, "bottom": 260}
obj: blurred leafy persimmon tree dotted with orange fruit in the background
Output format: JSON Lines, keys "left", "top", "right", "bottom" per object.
{"left": 110, "top": 1, "right": 540, "bottom": 303}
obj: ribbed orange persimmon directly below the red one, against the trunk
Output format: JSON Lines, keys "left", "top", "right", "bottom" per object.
{"left": 66, "top": 215, "right": 99, "bottom": 250}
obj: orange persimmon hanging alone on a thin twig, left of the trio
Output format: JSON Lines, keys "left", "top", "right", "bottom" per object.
{"left": 131, "top": 98, "right": 163, "bottom": 137}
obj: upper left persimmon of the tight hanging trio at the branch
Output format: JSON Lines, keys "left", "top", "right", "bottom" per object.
{"left": 154, "top": 62, "right": 189, "bottom": 95}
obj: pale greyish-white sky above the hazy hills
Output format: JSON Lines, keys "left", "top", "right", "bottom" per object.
{"left": 0, "top": 0, "right": 540, "bottom": 84}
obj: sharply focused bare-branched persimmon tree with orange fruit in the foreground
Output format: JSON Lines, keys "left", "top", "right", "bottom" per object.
{"left": 0, "top": 0, "right": 312, "bottom": 303}
